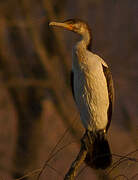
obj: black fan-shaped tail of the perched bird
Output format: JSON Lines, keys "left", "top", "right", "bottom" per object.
{"left": 85, "top": 131, "right": 112, "bottom": 169}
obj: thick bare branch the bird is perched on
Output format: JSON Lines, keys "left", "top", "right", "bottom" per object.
{"left": 64, "top": 134, "right": 87, "bottom": 180}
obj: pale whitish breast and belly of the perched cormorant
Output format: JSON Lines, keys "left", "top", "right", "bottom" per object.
{"left": 72, "top": 50, "right": 109, "bottom": 131}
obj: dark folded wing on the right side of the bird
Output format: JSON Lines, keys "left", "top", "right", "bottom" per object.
{"left": 103, "top": 65, "right": 114, "bottom": 131}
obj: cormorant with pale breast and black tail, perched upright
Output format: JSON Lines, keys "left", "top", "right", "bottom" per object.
{"left": 49, "top": 18, "right": 114, "bottom": 169}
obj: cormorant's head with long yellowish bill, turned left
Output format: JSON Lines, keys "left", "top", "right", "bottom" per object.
{"left": 49, "top": 19, "right": 90, "bottom": 35}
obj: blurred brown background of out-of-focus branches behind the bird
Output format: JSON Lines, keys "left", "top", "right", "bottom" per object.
{"left": 0, "top": 0, "right": 138, "bottom": 180}
